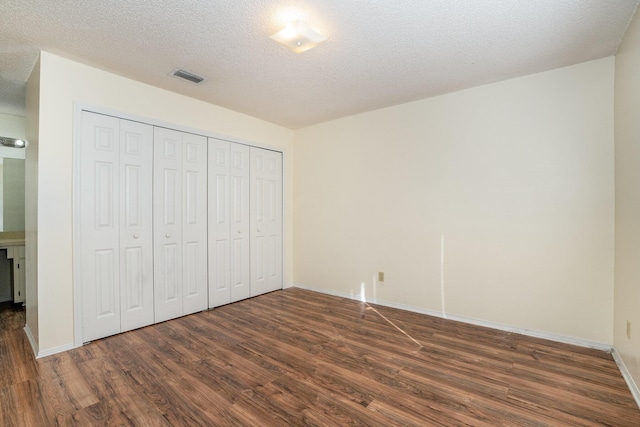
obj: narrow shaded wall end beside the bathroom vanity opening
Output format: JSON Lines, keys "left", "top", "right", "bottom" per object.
{"left": 24, "top": 55, "right": 40, "bottom": 351}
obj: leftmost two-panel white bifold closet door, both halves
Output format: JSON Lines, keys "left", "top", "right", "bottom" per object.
{"left": 79, "top": 112, "right": 154, "bottom": 341}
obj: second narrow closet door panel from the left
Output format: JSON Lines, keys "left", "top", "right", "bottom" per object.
{"left": 120, "top": 120, "right": 154, "bottom": 332}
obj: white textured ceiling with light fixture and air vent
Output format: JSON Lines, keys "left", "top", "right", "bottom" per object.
{"left": 0, "top": 0, "right": 638, "bottom": 129}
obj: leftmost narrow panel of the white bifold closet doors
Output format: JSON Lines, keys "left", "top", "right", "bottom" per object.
{"left": 79, "top": 111, "right": 120, "bottom": 341}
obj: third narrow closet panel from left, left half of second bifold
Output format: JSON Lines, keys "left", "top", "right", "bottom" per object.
{"left": 153, "top": 127, "right": 184, "bottom": 322}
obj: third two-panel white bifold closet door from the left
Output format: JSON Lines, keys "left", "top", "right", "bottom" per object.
{"left": 209, "top": 138, "right": 251, "bottom": 307}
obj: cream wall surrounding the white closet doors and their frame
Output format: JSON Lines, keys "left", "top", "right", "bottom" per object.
{"left": 33, "top": 52, "right": 293, "bottom": 352}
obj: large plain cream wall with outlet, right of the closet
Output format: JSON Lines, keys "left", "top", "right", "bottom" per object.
{"left": 294, "top": 57, "right": 614, "bottom": 345}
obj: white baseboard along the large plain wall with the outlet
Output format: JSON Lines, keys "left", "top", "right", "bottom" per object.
{"left": 293, "top": 283, "right": 612, "bottom": 352}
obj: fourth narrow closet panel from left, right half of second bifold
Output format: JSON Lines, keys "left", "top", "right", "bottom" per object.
{"left": 182, "top": 133, "right": 209, "bottom": 314}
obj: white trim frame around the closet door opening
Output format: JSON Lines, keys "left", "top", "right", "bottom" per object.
{"left": 72, "top": 102, "right": 288, "bottom": 347}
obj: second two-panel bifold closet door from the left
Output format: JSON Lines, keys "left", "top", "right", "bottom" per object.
{"left": 153, "top": 127, "right": 208, "bottom": 322}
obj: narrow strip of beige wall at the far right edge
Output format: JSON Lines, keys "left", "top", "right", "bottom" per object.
{"left": 613, "top": 6, "right": 640, "bottom": 394}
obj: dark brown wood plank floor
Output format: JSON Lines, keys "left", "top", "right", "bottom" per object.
{"left": 0, "top": 288, "right": 640, "bottom": 427}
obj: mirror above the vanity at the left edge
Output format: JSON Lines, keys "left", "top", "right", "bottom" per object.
{"left": 0, "top": 147, "right": 25, "bottom": 231}
